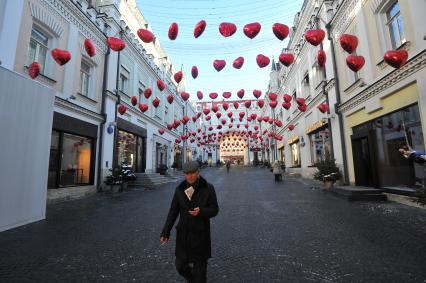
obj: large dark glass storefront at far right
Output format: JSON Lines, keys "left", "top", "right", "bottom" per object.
{"left": 351, "top": 104, "right": 425, "bottom": 187}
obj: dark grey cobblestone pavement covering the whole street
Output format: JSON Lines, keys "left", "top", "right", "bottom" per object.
{"left": 0, "top": 167, "right": 426, "bottom": 282}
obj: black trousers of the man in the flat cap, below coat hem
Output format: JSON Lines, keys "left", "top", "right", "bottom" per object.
{"left": 175, "top": 257, "right": 207, "bottom": 283}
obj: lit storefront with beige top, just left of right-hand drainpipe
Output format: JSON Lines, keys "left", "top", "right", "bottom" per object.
{"left": 305, "top": 120, "right": 331, "bottom": 165}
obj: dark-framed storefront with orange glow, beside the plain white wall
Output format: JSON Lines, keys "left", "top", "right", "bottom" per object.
{"left": 48, "top": 112, "right": 98, "bottom": 189}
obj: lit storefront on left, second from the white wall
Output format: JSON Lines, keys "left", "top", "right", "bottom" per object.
{"left": 117, "top": 118, "right": 146, "bottom": 172}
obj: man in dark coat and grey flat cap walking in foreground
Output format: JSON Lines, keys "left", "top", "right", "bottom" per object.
{"left": 160, "top": 161, "right": 219, "bottom": 282}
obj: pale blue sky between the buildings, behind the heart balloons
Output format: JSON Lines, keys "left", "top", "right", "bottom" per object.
{"left": 136, "top": 0, "right": 303, "bottom": 101}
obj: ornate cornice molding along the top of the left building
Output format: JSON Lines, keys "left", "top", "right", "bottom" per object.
{"left": 39, "top": 0, "right": 108, "bottom": 53}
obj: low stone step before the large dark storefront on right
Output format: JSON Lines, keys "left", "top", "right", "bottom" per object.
{"left": 331, "top": 186, "right": 387, "bottom": 201}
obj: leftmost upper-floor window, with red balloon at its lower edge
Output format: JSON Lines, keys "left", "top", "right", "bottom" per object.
{"left": 28, "top": 27, "right": 49, "bottom": 74}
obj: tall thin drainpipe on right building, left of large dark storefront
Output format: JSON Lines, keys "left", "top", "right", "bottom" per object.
{"left": 325, "top": 22, "right": 349, "bottom": 185}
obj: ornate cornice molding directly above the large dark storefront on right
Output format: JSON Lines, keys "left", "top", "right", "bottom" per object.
{"left": 337, "top": 50, "right": 426, "bottom": 113}
